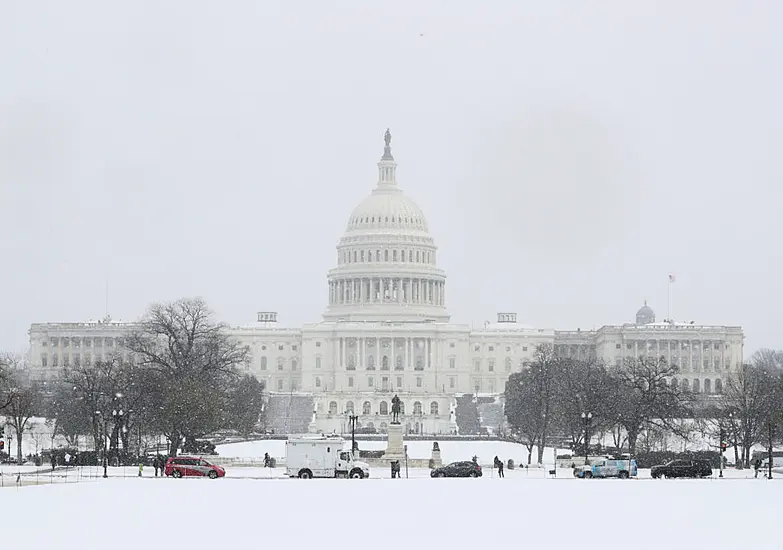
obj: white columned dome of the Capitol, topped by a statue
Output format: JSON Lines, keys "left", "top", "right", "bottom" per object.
{"left": 324, "top": 130, "right": 449, "bottom": 322}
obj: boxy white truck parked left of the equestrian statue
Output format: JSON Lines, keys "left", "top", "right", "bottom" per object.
{"left": 285, "top": 436, "right": 370, "bottom": 479}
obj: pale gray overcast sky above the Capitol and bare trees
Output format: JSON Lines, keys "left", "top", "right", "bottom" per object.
{"left": 0, "top": 0, "right": 783, "bottom": 353}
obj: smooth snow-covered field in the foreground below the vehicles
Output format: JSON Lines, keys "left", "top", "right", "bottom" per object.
{"left": 0, "top": 468, "right": 783, "bottom": 550}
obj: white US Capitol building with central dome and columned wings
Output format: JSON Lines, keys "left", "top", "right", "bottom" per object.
{"left": 29, "top": 130, "right": 744, "bottom": 434}
